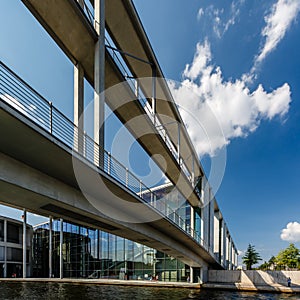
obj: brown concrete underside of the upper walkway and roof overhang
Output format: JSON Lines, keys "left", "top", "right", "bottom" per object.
{"left": 22, "top": 0, "right": 201, "bottom": 206}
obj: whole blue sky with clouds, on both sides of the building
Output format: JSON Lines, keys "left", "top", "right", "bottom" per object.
{"left": 0, "top": 0, "right": 300, "bottom": 259}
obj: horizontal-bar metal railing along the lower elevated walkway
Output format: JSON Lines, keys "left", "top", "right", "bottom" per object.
{"left": 0, "top": 61, "right": 213, "bottom": 255}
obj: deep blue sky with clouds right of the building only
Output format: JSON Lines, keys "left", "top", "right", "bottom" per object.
{"left": 135, "top": 0, "right": 300, "bottom": 259}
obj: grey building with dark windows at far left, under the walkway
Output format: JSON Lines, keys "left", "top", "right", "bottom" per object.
{"left": 0, "top": 216, "right": 33, "bottom": 278}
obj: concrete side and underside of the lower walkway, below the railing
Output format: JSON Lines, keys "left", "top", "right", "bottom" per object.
{"left": 0, "top": 101, "right": 221, "bottom": 268}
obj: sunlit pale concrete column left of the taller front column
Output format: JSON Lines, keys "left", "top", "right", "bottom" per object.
{"left": 74, "top": 63, "right": 84, "bottom": 153}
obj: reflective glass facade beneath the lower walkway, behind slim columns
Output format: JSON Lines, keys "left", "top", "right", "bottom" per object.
{"left": 33, "top": 220, "right": 190, "bottom": 281}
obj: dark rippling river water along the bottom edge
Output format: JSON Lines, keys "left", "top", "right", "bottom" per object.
{"left": 0, "top": 282, "right": 300, "bottom": 300}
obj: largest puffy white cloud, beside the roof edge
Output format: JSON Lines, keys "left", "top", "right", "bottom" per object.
{"left": 170, "top": 40, "right": 291, "bottom": 156}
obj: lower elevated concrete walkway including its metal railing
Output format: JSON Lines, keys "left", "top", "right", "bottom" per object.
{"left": 0, "top": 60, "right": 221, "bottom": 268}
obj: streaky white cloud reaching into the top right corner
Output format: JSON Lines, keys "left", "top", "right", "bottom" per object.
{"left": 254, "top": 0, "right": 300, "bottom": 69}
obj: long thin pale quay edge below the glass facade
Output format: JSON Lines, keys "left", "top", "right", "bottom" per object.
{"left": 0, "top": 278, "right": 200, "bottom": 289}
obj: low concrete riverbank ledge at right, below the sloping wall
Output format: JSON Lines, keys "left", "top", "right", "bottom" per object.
{"left": 201, "top": 282, "right": 300, "bottom": 294}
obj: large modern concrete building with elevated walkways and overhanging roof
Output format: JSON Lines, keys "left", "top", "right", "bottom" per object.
{"left": 0, "top": 0, "right": 237, "bottom": 281}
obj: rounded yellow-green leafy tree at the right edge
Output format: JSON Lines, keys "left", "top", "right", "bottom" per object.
{"left": 275, "top": 244, "right": 300, "bottom": 269}
